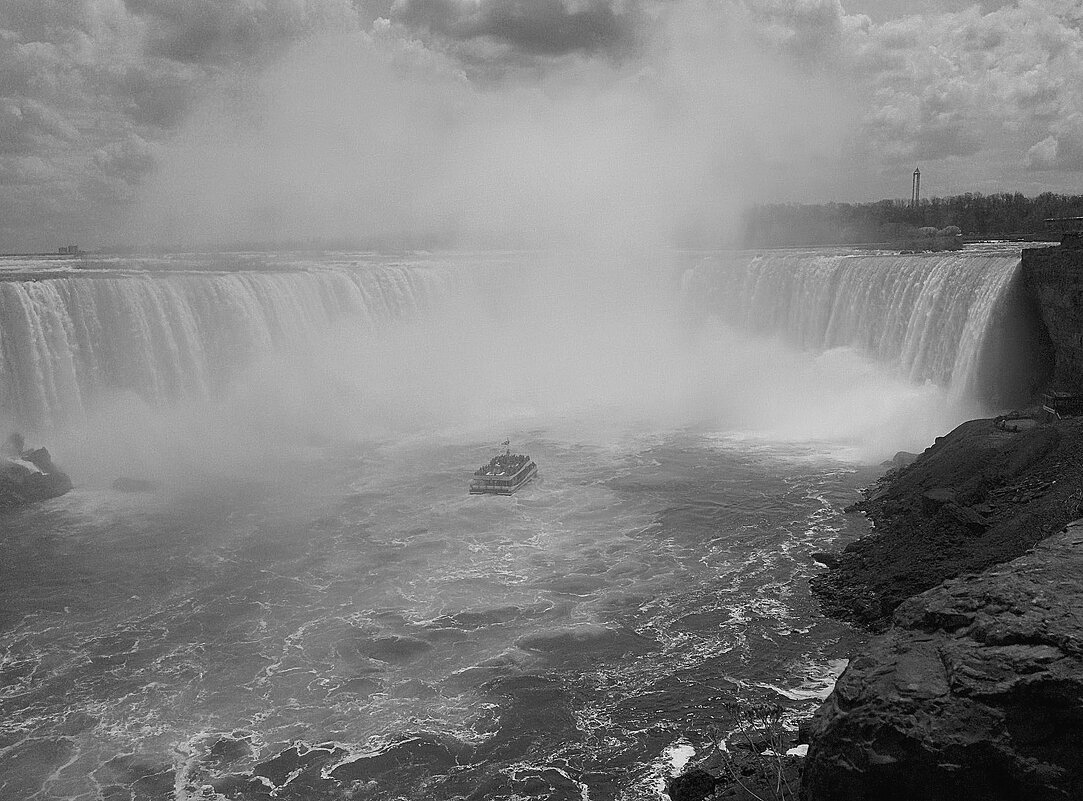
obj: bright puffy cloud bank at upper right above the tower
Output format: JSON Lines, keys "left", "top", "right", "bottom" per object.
{"left": 841, "top": 0, "right": 1083, "bottom": 185}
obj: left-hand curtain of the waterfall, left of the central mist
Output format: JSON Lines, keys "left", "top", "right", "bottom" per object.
{"left": 0, "top": 263, "right": 454, "bottom": 430}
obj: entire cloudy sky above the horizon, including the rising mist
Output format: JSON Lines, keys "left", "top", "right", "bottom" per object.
{"left": 0, "top": 0, "right": 1083, "bottom": 252}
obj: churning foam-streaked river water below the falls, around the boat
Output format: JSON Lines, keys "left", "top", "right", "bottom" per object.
{"left": 0, "top": 435, "right": 875, "bottom": 799}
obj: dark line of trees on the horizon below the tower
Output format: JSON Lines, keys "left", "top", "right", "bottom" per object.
{"left": 742, "top": 192, "right": 1083, "bottom": 247}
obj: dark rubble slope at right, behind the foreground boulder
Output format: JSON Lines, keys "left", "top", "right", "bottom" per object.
{"left": 812, "top": 418, "right": 1083, "bottom": 631}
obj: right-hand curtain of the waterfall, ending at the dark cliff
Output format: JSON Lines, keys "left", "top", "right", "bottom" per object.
{"left": 683, "top": 252, "right": 1019, "bottom": 397}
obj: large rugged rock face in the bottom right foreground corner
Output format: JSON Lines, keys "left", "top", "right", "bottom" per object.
{"left": 803, "top": 521, "right": 1083, "bottom": 801}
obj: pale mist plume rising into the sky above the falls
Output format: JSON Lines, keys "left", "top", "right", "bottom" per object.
{"left": 128, "top": 2, "right": 852, "bottom": 249}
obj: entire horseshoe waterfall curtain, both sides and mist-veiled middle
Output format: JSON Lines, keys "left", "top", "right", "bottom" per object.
{"left": 0, "top": 252, "right": 1026, "bottom": 432}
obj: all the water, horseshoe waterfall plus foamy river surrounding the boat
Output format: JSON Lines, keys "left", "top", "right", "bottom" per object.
{"left": 0, "top": 246, "right": 1044, "bottom": 801}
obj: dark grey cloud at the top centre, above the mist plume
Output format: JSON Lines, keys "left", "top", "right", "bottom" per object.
{"left": 391, "top": 0, "right": 641, "bottom": 55}
